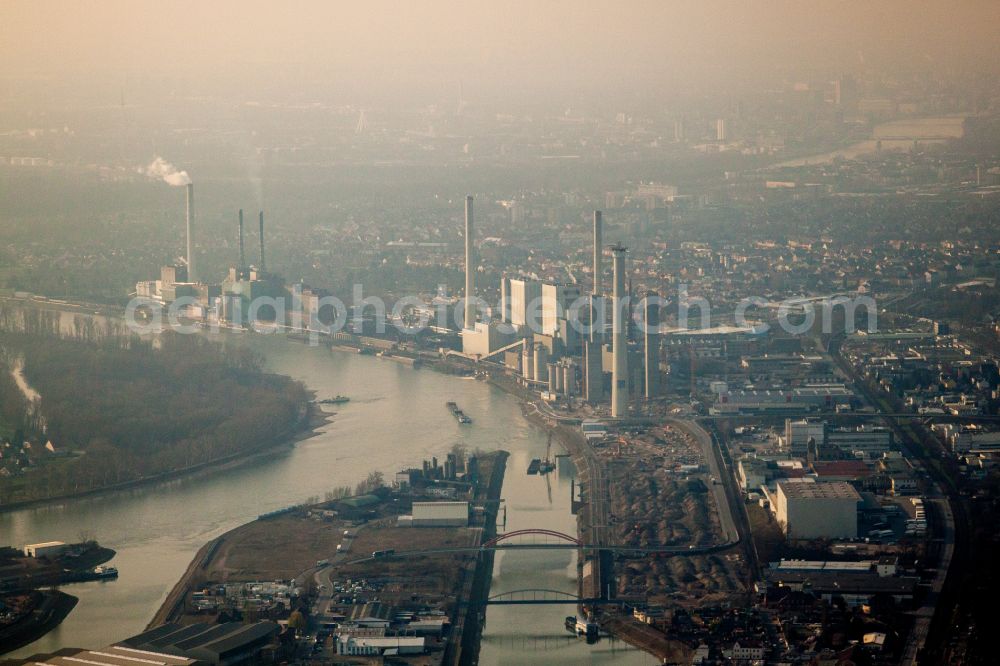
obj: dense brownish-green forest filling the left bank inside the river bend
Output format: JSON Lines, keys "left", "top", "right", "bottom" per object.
{"left": 0, "top": 310, "right": 309, "bottom": 504}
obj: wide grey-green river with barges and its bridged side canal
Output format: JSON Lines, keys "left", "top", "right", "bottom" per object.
{"left": 0, "top": 334, "right": 655, "bottom": 664}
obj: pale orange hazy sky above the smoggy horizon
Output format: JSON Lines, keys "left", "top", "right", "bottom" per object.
{"left": 0, "top": 0, "right": 1000, "bottom": 102}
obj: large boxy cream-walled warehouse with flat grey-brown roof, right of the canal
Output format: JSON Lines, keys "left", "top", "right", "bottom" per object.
{"left": 772, "top": 481, "right": 861, "bottom": 539}
